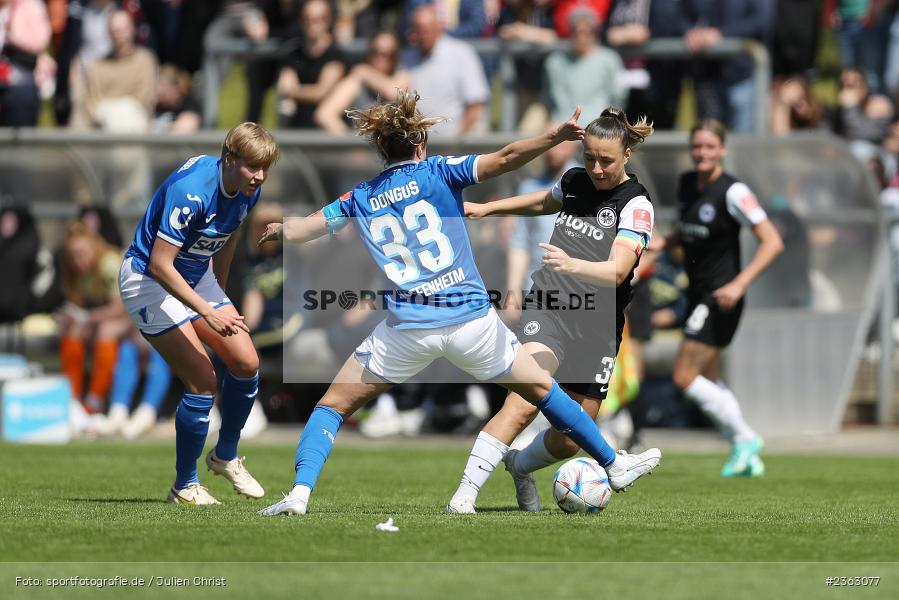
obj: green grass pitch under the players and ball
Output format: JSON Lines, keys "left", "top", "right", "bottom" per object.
{"left": 0, "top": 442, "right": 899, "bottom": 599}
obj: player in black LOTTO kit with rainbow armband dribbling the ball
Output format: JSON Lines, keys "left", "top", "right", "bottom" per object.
{"left": 449, "top": 108, "right": 660, "bottom": 513}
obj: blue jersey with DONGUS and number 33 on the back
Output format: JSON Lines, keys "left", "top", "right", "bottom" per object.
{"left": 324, "top": 155, "right": 490, "bottom": 329}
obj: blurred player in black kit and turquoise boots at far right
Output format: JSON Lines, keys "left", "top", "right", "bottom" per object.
{"left": 659, "top": 119, "right": 783, "bottom": 477}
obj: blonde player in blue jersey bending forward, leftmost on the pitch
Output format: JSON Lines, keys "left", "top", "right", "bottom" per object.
{"left": 119, "top": 123, "right": 278, "bottom": 505}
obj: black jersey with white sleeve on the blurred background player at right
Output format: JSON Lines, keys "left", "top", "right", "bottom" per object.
{"left": 677, "top": 171, "right": 768, "bottom": 296}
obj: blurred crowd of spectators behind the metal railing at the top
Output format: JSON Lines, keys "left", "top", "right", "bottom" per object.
{"left": 0, "top": 0, "right": 884, "bottom": 142}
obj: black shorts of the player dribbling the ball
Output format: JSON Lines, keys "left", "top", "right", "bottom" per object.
{"left": 515, "top": 310, "right": 624, "bottom": 400}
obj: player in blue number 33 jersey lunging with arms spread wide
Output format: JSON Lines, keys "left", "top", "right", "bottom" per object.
{"left": 259, "top": 91, "right": 658, "bottom": 516}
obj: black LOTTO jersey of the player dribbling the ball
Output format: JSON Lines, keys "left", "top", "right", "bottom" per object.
{"left": 533, "top": 167, "right": 653, "bottom": 311}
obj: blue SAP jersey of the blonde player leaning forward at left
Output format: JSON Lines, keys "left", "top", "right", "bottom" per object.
{"left": 125, "top": 156, "right": 262, "bottom": 287}
